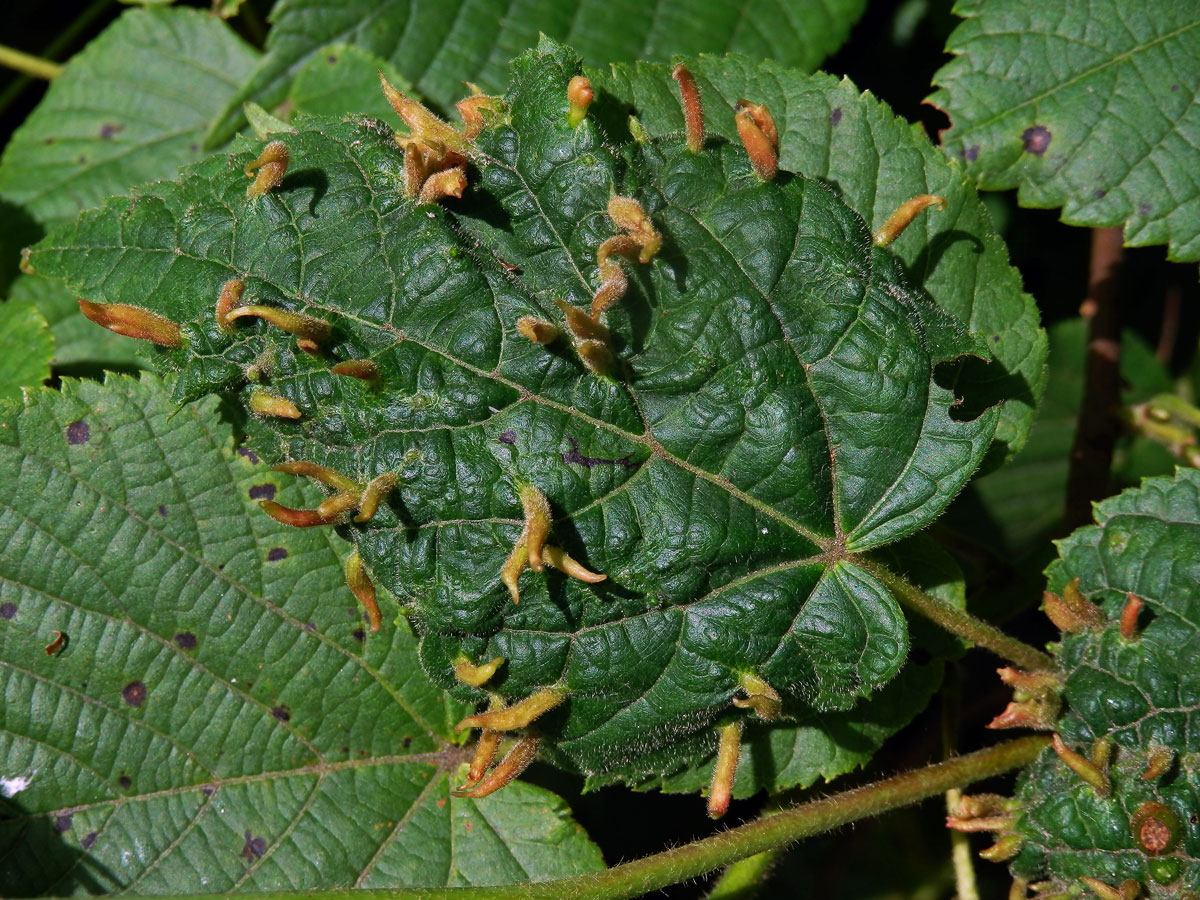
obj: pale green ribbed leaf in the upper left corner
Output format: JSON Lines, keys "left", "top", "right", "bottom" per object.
{"left": 0, "top": 8, "right": 256, "bottom": 230}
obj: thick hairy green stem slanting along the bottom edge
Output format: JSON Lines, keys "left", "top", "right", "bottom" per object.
{"left": 23, "top": 736, "right": 1049, "bottom": 900}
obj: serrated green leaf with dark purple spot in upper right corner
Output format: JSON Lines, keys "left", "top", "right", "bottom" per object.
{"left": 929, "top": 0, "right": 1200, "bottom": 260}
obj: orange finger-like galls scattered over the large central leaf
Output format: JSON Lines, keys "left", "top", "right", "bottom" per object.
{"left": 72, "top": 58, "right": 944, "bottom": 817}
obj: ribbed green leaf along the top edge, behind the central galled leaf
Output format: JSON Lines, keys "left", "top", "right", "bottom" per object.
{"left": 208, "top": 0, "right": 866, "bottom": 146}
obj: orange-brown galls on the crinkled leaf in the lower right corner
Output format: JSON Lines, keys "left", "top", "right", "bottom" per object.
{"left": 946, "top": 578, "right": 1200, "bottom": 900}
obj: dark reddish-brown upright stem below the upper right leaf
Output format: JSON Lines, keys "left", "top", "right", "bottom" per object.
{"left": 1063, "top": 228, "right": 1124, "bottom": 532}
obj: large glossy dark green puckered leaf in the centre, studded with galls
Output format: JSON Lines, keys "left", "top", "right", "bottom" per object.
{"left": 32, "top": 41, "right": 997, "bottom": 787}
